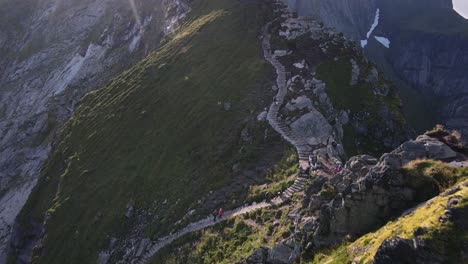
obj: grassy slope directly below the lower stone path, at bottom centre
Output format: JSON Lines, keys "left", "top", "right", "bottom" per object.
{"left": 150, "top": 201, "right": 298, "bottom": 264}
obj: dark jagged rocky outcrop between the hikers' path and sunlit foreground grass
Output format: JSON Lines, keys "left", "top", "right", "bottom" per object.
{"left": 304, "top": 135, "right": 461, "bottom": 246}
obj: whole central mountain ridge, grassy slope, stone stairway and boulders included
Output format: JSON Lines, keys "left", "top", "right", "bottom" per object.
{"left": 9, "top": 0, "right": 414, "bottom": 263}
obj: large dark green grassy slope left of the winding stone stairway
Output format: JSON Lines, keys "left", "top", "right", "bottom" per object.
{"left": 18, "top": 0, "right": 278, "bottom": 264}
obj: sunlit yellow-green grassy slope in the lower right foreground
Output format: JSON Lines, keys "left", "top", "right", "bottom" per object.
{"left": 313, "top": 166, "right": 468, "bottom": 264}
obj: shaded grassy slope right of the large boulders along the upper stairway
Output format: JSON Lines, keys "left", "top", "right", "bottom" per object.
{"left": 317, "top": 57, "right": 406, "bottom": 156}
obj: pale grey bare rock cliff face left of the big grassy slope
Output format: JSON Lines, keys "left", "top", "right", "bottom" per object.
{"left": 0, "top": 0, "right": 189, "bottom": 262}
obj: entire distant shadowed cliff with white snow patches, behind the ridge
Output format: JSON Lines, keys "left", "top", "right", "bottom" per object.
{"left": 288, "top": 0, "right": 468, "bottom": 142}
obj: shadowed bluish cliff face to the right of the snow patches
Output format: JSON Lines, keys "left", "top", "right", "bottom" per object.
{"left": 369, "top": 1, "right": 468, "bottom": 140}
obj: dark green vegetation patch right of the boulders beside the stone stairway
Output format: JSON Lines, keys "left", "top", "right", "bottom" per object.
{"left": 316, "top": 55, "right": 406, "bottom": 156}
